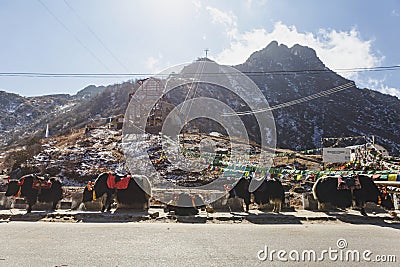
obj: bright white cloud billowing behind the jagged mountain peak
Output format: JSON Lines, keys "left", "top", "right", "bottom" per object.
{"left": 207, "top": 7, "right": 399, "bottom": 96}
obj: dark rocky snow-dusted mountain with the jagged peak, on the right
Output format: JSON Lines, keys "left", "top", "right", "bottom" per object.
{"left": 236, "top": 42, "right": 400, "bottom": 155}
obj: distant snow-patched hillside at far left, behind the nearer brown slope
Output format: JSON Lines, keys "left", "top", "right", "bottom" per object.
{"left": 0, "top": 82, "right": 126, "bottom": 147}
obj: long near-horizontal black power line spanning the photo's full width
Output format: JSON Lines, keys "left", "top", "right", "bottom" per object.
{"left": 0, "top": 65, "right": 400, "bottom": 78}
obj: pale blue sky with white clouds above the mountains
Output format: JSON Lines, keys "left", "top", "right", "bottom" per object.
{"left": 0, "top": 0, "right": 400, "bottom": 97}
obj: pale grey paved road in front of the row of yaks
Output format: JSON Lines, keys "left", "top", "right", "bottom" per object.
{"left": 0, "top": 222, "right": 400, "bottom": 267}
